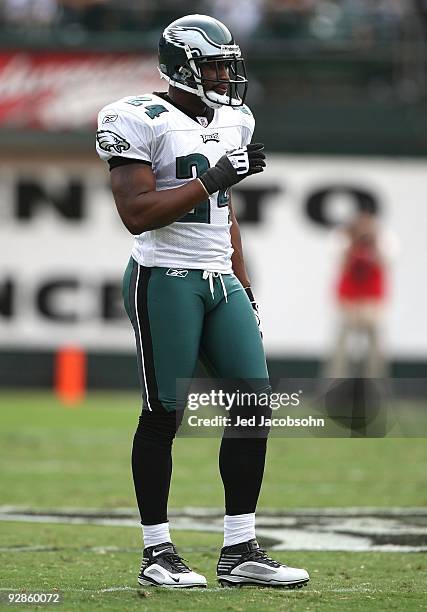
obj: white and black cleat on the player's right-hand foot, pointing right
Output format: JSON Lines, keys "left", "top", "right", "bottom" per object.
{"left": 217, "top": 540, "right": 310, "bottom": 589}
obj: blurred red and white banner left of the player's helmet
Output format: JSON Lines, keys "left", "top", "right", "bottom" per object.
{"left": 0, "top": 51, "right": 164, "bottom": 131}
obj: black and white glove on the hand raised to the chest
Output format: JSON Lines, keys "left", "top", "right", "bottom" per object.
{"left": 199, "top": 143, "right": 265, "bottom": 195}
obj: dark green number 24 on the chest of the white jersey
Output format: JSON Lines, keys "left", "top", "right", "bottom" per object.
{"left": 176, "top": 153, "right": 230, "bottom": 223}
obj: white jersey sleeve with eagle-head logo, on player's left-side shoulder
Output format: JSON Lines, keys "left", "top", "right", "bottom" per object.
{"left": 96, "top": 107, "right": 154, "bottom": 163}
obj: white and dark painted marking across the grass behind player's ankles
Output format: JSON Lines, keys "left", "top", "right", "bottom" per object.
{"left": 0, "top": 506, "right": 427, "bottom": 552}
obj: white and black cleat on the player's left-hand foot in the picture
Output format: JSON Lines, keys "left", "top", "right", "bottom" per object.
{"left": 138, "top": 542, "right": 207, "bottom": 589}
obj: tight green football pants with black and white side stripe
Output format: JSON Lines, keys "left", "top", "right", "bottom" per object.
{"left": 123, "top": 258, "right": 268, "bottom": 411}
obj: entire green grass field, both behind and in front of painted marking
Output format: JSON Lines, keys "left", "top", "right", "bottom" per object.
{"left": 0, "top": 393, "right": 427, "bottom": 611}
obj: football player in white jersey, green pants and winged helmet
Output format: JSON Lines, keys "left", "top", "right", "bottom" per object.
{"left": 97, "top": 15, "right": 309, "bottom": 588}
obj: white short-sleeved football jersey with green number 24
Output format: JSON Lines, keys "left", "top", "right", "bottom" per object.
{"left": 96, "top": 94, "right": 255, "bottom": 274}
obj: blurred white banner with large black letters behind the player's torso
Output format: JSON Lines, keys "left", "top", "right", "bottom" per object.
{"left": 0, "top": 154, "right": 427, "bottom": 359}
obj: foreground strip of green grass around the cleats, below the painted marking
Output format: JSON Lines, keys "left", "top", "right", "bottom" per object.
{"left": 2, "top": 523, "right": 426, "bottom": 612}
